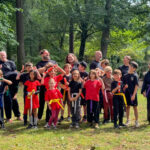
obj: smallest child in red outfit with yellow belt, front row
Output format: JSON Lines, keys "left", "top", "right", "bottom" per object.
{"left": 45, "top": 78, "right": 63, "bottom": 129}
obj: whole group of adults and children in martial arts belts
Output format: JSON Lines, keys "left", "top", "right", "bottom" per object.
{"left": 0, "top": 49, "right": 150, "bottom": 129}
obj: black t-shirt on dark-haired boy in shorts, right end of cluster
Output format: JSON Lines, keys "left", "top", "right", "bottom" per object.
{"left": 123, "top": 74, "right": 138, "bottom": 95}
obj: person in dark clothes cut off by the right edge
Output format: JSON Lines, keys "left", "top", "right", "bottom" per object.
{"left": 141, "top": 62, "right": 150, "bottom": 125}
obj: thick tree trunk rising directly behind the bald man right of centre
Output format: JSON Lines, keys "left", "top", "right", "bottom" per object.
{"left": 101, "top": 0, "right": 112, "bottom": 58}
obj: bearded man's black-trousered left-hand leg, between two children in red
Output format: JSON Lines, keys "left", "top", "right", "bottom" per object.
{"left": 38, "top": 86, "right": 45, "bottom": 119}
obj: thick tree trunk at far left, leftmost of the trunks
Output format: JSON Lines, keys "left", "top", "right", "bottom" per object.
{"left": 16, "top": 0, "right": 25, "bottom": 69}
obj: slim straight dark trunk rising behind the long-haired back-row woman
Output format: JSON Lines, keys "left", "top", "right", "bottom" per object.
{"left": 69, "top": 18, "right": 74, "bottom": 53}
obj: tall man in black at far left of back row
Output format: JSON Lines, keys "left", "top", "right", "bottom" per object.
{"left": 0, "top": 51, "right": 21, "bottom": 122}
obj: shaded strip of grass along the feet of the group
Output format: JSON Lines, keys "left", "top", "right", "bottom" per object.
{"left": 0, "top": 120, "right": 149, "bottom": 136}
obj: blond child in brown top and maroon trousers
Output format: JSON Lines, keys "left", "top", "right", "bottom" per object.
{"left": 103, "top": 66, "right": 113, "bottom": 123}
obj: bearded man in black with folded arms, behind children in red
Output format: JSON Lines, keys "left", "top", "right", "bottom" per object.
{"left": 36, "top": 49, "right": 56, "bottom": 122}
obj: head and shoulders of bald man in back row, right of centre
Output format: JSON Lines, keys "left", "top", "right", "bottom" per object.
{"left": 90, "top": 51, "right": 102, "bottom": 70}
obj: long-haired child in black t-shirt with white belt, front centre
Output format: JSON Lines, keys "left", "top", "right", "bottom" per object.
{"left": 68, "top": 70, "right": 82, "bottom": 128}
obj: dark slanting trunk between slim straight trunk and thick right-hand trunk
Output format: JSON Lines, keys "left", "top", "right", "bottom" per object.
{"left": 79, "top": 23, "right": 88, "bottom": 61}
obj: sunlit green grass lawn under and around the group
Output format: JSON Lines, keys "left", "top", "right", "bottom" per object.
{"left": 0, "top": 88, "right": 150, "bottom": 150}
